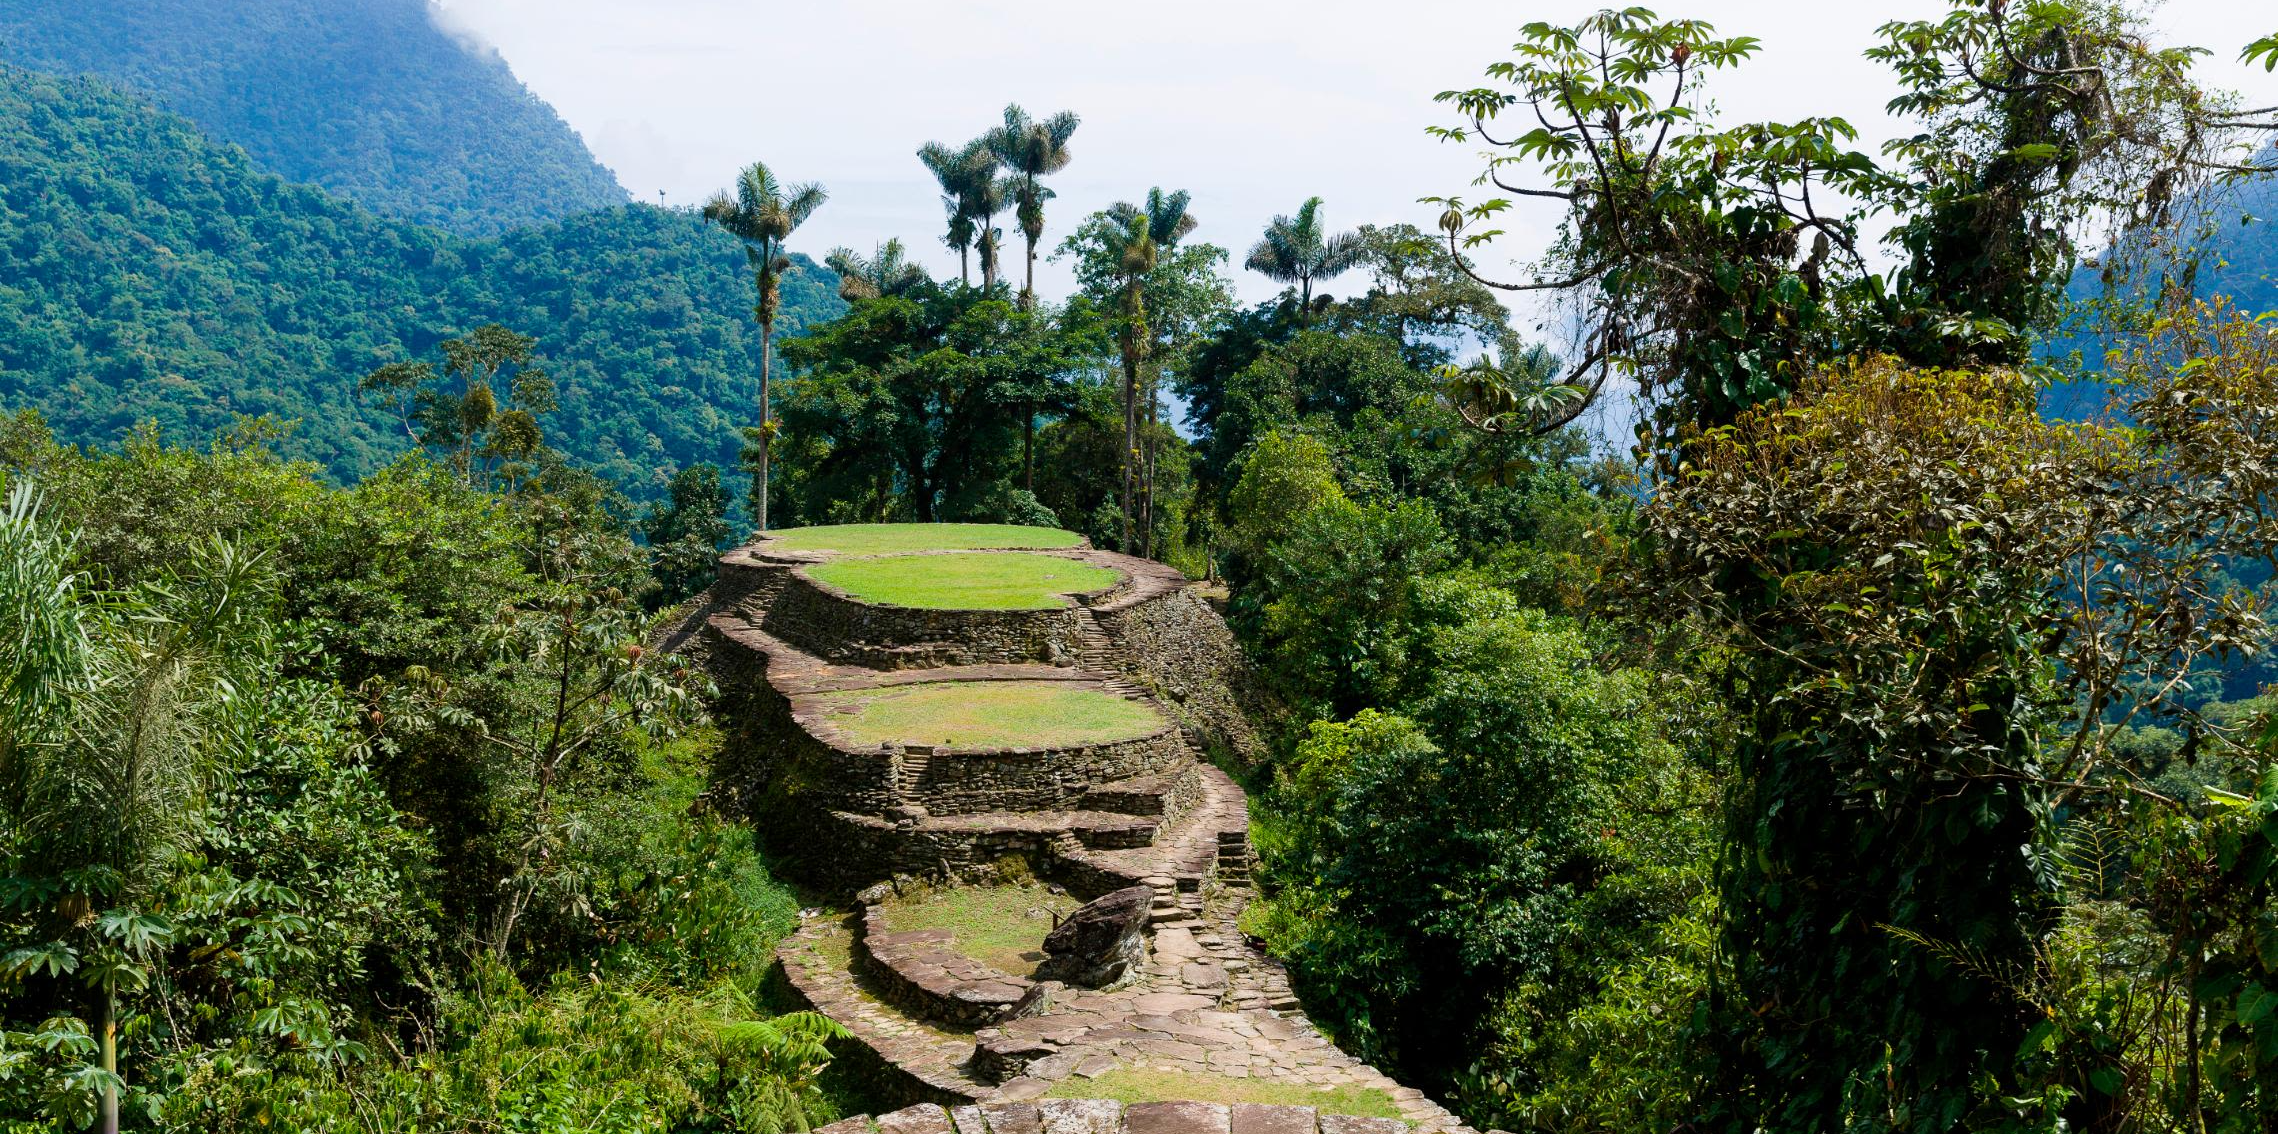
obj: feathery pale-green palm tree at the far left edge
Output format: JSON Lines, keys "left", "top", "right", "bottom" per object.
{"left": 0, "top": 483, "right": 267, "bottom": 1134}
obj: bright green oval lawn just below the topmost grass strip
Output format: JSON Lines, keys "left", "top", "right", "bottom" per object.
{"left": 806, "top": 551, "right": 1121, "bottom": 610}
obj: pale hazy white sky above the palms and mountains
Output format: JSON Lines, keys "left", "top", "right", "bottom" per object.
{"left": 442, "top": 0, "right": 2278, "bottom": 309}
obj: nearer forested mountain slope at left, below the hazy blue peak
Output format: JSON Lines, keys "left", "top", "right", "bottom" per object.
{"left": 0, "top": 68, "right": 841, "bottom": 496}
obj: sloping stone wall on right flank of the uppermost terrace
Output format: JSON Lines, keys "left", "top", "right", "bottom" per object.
{"left": 1093, "top": 587, "right": 1264, "bottom": 763}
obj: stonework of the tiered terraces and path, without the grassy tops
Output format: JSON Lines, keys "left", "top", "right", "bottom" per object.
{"left": 663, "top": 530, "right": 1467, "bottom": 1134}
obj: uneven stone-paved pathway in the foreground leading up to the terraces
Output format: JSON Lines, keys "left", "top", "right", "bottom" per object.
{"left": 781, "top": 884, "right": 1469, "bottom": 1134}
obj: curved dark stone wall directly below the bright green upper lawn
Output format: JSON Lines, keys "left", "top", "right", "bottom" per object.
{"left": 761, "top": 569, "right": 1077, "bottom": 669}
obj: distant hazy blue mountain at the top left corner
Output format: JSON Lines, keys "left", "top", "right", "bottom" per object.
{"left": 0, "top": 0, "right": 626, "bottom": 235}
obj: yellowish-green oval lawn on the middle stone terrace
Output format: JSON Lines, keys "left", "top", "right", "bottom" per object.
{"left": 818, "top": 681, "right": 1162, "bottom": 749}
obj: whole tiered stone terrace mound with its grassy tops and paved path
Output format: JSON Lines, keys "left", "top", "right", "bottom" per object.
{"left": 687, "top": 524, "right": 1467, "bottom": 1134}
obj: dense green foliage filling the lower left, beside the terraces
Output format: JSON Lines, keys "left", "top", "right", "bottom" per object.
{"left": 0, "top": 417, "right": 856, "bottom": 1134}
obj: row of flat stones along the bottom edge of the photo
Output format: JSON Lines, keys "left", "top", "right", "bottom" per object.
{"left": 816, "top": 1098, "right": 1408, "bottom": 1134}
